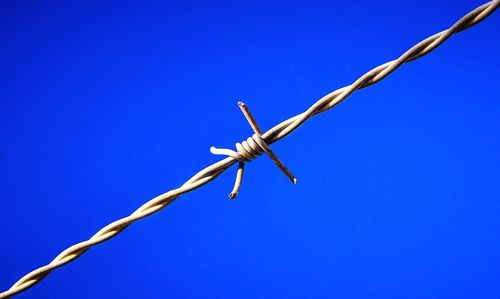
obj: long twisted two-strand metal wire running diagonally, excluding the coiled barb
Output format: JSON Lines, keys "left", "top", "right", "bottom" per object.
{"left": 0, "top": 0, "right": 500, "bottom": 298}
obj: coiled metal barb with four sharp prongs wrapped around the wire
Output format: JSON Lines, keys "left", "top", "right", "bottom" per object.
{"left": 210, "top": 102, "right": 297, "bottom": 199}
